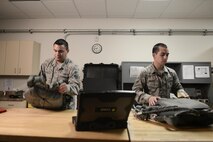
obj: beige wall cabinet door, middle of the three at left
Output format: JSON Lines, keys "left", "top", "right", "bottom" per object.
{"left": 4, "top": 41, "right": 19, "bottom": 75}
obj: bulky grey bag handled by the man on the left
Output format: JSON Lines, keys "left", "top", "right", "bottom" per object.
{"left": 24, "top": 76, "right": 72, "bottom": 110}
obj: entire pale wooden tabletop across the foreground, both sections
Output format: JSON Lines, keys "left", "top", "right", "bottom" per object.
{"left": 0, "top": 108, "right": 213, "bottom": 142}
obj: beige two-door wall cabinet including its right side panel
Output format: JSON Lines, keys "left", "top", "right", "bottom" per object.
{"left": 2, "top": 41, "right": 40, "bottom": 75}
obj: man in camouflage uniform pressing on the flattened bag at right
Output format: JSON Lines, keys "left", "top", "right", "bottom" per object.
{"left": 132, "top": 43, "right": 189, "bottom": 105}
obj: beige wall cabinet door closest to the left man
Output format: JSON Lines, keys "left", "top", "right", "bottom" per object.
{"left": 18, "top": 41, "right": 33, "bottom": 75}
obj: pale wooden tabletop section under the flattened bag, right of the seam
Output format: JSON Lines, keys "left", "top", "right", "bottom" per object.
{"left": 128, "top": 114, "right": 213, "bottom": 142}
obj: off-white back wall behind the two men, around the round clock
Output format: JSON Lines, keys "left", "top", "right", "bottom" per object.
{"left": 0, "top": 19, "right": 213, "bottom": 90}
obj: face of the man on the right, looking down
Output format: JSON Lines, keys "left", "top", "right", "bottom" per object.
{"left": 153, "top": 47, "right": 169, "bottom": 66}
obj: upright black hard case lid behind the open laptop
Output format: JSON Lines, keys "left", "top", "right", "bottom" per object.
{"left": 83, "top": 63, "right": 120, "bottom": 91}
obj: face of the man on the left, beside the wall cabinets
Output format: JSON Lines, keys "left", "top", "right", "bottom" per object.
{"left": 53, "top": 44, "right": 68, "bottom": 63}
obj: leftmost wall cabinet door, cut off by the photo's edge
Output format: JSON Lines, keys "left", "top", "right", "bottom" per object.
{"left": 0, "top": 41, "right": 6, "bottom": 75}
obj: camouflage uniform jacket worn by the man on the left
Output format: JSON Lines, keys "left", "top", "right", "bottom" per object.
{"left": 40, "top": 58, "right": 80, "bottom": 95}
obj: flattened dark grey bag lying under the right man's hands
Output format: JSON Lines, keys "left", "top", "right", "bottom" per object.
{"left": 133, "top": 98, "right": 213, "bottom": 127}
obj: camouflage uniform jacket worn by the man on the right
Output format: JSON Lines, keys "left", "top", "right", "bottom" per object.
{"left": 132, "top": 64, "right": 183, "bottom": 104}
